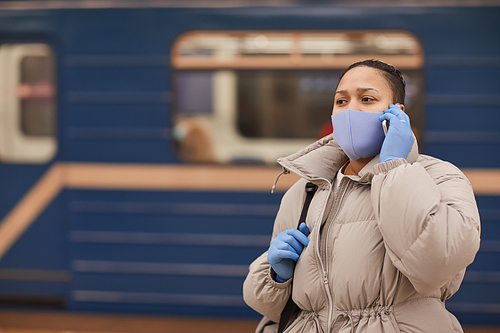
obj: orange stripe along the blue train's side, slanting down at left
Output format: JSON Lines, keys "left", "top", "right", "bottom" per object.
{"left": 0, "top": 163, "right": 500, "bottom": 259}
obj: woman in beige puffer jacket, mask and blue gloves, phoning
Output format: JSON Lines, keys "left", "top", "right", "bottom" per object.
{"left": 243, "top": 60, "right": 480, "bottom": 333}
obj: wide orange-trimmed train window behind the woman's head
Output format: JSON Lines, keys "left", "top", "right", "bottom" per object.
{"left": 172, "top": 31, "right": 423, "bottom": 164}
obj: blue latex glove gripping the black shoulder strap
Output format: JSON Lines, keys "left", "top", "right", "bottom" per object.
{"left": 267, "top": 222, "right": 309, "bottom": 282}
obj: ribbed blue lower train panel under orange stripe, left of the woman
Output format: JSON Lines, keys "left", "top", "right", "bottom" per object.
{"left": 68, "top": 191, "right": 279, "bottom": 316}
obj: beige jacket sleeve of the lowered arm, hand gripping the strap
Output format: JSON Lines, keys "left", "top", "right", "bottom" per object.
{"left": 243, "top": 179, "right": 306, "bottom": 322}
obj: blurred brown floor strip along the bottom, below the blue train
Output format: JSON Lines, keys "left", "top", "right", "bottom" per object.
{"left": 0, "top": 310, "right": 500, "bottom": 333}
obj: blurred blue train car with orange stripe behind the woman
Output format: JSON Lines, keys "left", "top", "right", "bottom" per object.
{"left": 0, "top": 1, "right": 500, "bottom": 325}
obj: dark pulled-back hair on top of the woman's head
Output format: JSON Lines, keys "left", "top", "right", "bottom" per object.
{"left": 340, "top": 59, "right": 406, "bottom": 104}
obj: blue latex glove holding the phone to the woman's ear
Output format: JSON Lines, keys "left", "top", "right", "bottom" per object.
{"left": 378, "top": 104, "right": 415, "bottom": 163}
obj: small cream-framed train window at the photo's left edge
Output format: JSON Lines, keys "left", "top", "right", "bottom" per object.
{"left": 0, "top": 44, "right": 57, "bottom": 164}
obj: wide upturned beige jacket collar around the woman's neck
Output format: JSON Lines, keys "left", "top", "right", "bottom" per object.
{"left": 278, "top": 135, "right": 418, "bottom": 185}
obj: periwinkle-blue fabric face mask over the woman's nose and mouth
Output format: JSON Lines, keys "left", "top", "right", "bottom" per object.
{"left": 332, "top": 109, "right": 385, "bottom": 161}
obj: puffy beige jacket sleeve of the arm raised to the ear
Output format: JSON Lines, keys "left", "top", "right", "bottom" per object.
{"left": 372, "top": 157, "right": 480, "bottom": 293}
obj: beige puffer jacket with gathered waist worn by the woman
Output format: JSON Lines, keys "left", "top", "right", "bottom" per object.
{"left": 243, "top": 136, "right": 480, "bottom": 333}
